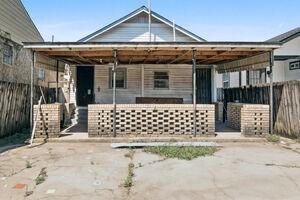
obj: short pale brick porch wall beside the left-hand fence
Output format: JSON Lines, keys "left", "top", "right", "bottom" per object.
{"left": 33, "top": 104, "right": 63, "bottom": 138}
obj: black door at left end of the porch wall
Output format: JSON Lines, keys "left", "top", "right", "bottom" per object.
{"left": 76, "top": 66, "right": 94, "bottom": 106}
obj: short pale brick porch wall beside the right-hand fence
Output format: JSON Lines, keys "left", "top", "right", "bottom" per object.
{"left": 227, "top": 103, "right": 270, "bottom": 136}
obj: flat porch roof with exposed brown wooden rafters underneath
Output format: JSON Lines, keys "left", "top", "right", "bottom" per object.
{"left": 24, "top": 42, "right": 281, "bottom": 69}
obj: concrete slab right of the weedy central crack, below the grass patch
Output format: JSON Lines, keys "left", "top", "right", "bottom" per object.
{"left": 130, "top": 144, "right": 300, "bottom": 200}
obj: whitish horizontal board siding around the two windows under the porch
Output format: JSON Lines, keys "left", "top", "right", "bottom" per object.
{"left": 78, "top": 65, "right": 192, "bottom": 104}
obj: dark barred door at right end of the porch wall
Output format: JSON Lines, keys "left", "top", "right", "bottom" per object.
{"left": 196, "top": 68, "right": 211, "bottom": 104}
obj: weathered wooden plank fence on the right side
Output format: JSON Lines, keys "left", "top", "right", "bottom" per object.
{"left": 222, "top": 81, "right": 300, "bottom": 138}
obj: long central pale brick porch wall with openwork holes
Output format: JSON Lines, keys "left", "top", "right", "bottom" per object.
{"left": 88, "top": 104, "right": 215, "bottom": 137}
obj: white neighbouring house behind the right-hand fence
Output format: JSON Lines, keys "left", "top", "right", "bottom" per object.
{"left": 217, "top": 27, "right": 300, "bottom": 88}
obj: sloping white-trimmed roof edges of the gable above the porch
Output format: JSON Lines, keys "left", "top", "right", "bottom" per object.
{"left": 78, "top": 6, "right": 206, "bottom": 42}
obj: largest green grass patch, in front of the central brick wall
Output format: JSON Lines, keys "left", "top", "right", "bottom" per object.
{"left": 144, "top": 146, "right": 218, "bottom": 160}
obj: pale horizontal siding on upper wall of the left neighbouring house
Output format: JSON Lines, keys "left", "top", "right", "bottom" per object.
{"left": 0, "top": 0, "right": 43, "bottom": 44}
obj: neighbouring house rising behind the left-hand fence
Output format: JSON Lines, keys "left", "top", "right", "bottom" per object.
{"left": 0, "top": 0, "right": 64, "bottom": 87}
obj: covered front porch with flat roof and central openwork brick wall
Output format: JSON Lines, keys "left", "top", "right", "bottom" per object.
{"left": 26, "top": 42, "right": 280, "bottom": 137}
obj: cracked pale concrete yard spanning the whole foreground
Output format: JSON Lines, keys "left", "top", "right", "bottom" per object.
{"left": 0, "top": 143, "right": 300, "bottom": 200}
